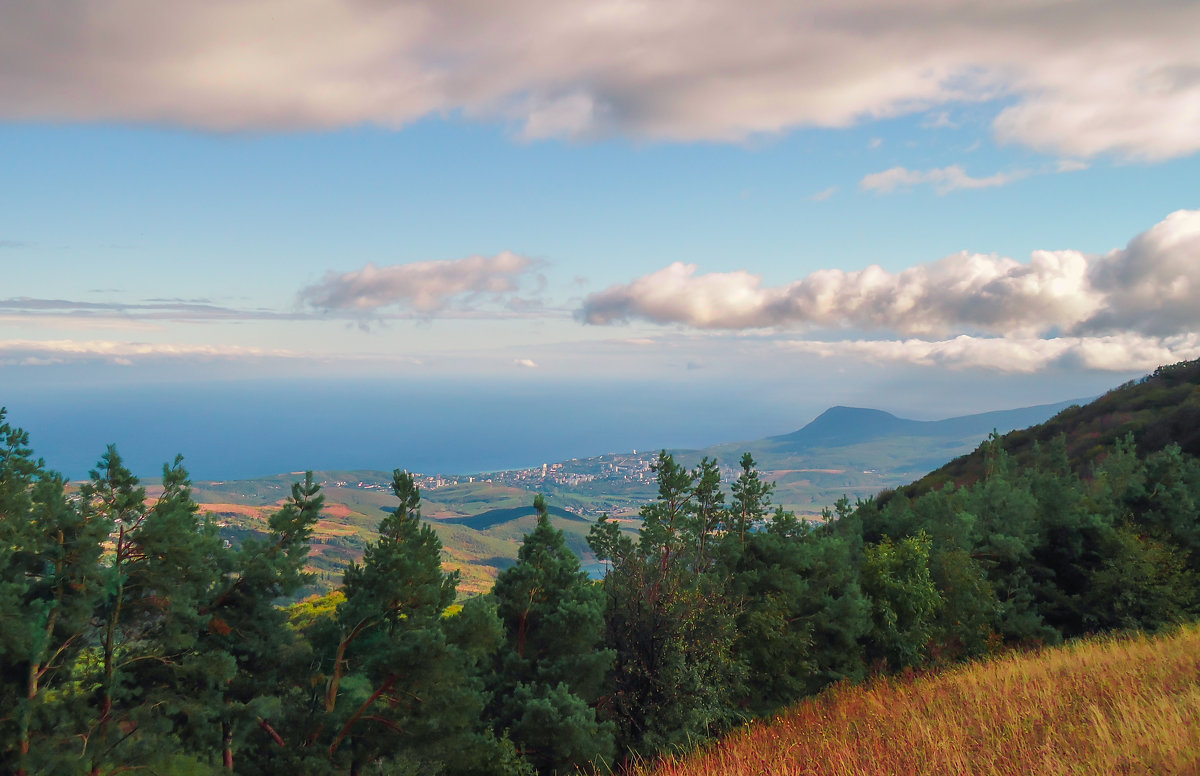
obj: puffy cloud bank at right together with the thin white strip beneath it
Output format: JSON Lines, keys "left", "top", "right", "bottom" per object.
{"left": 577, "top": 210, "right": 1200, "bottom": 372}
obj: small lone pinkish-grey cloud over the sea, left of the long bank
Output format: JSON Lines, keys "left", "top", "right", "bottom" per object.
{"left": 300, "top": 251, "right": 535, "bottom": 314}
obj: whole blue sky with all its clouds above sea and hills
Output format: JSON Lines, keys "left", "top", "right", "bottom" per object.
{"left": 0, "top": 0, "right": 1200, "bottom": 472}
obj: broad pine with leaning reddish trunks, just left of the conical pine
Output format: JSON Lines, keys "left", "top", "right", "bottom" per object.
{"left": 297, "top": 469, "right": 518, "bottom": 775}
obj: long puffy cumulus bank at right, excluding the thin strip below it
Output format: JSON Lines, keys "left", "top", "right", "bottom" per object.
{"left": 578, "top": 210, "right": 1200, "bottom": 336}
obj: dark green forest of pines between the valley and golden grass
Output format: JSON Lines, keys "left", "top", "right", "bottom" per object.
{"left": 0, "top": 362, "right": 1200, "bottom": 776}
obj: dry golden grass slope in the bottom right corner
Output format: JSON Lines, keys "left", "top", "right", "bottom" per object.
{"left": 637, "top": 626, "right": 1200, "bottom": 776}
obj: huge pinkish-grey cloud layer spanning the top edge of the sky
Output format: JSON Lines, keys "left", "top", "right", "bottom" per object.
{"left": 0, "top": 0, "right": 1200, "bottom": 160}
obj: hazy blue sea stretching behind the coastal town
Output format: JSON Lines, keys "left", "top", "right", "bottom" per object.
{"left": 0, "top": 380, "right": 823, "bottom": 480}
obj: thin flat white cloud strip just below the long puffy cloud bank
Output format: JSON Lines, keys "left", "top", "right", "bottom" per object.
{"left": 780, "top": 333, "right": 1200, "bottom": 373}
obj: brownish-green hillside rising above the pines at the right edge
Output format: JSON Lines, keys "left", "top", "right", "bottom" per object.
{"left": 900, "top": 360, "right": 1200, "bottom": 497}
